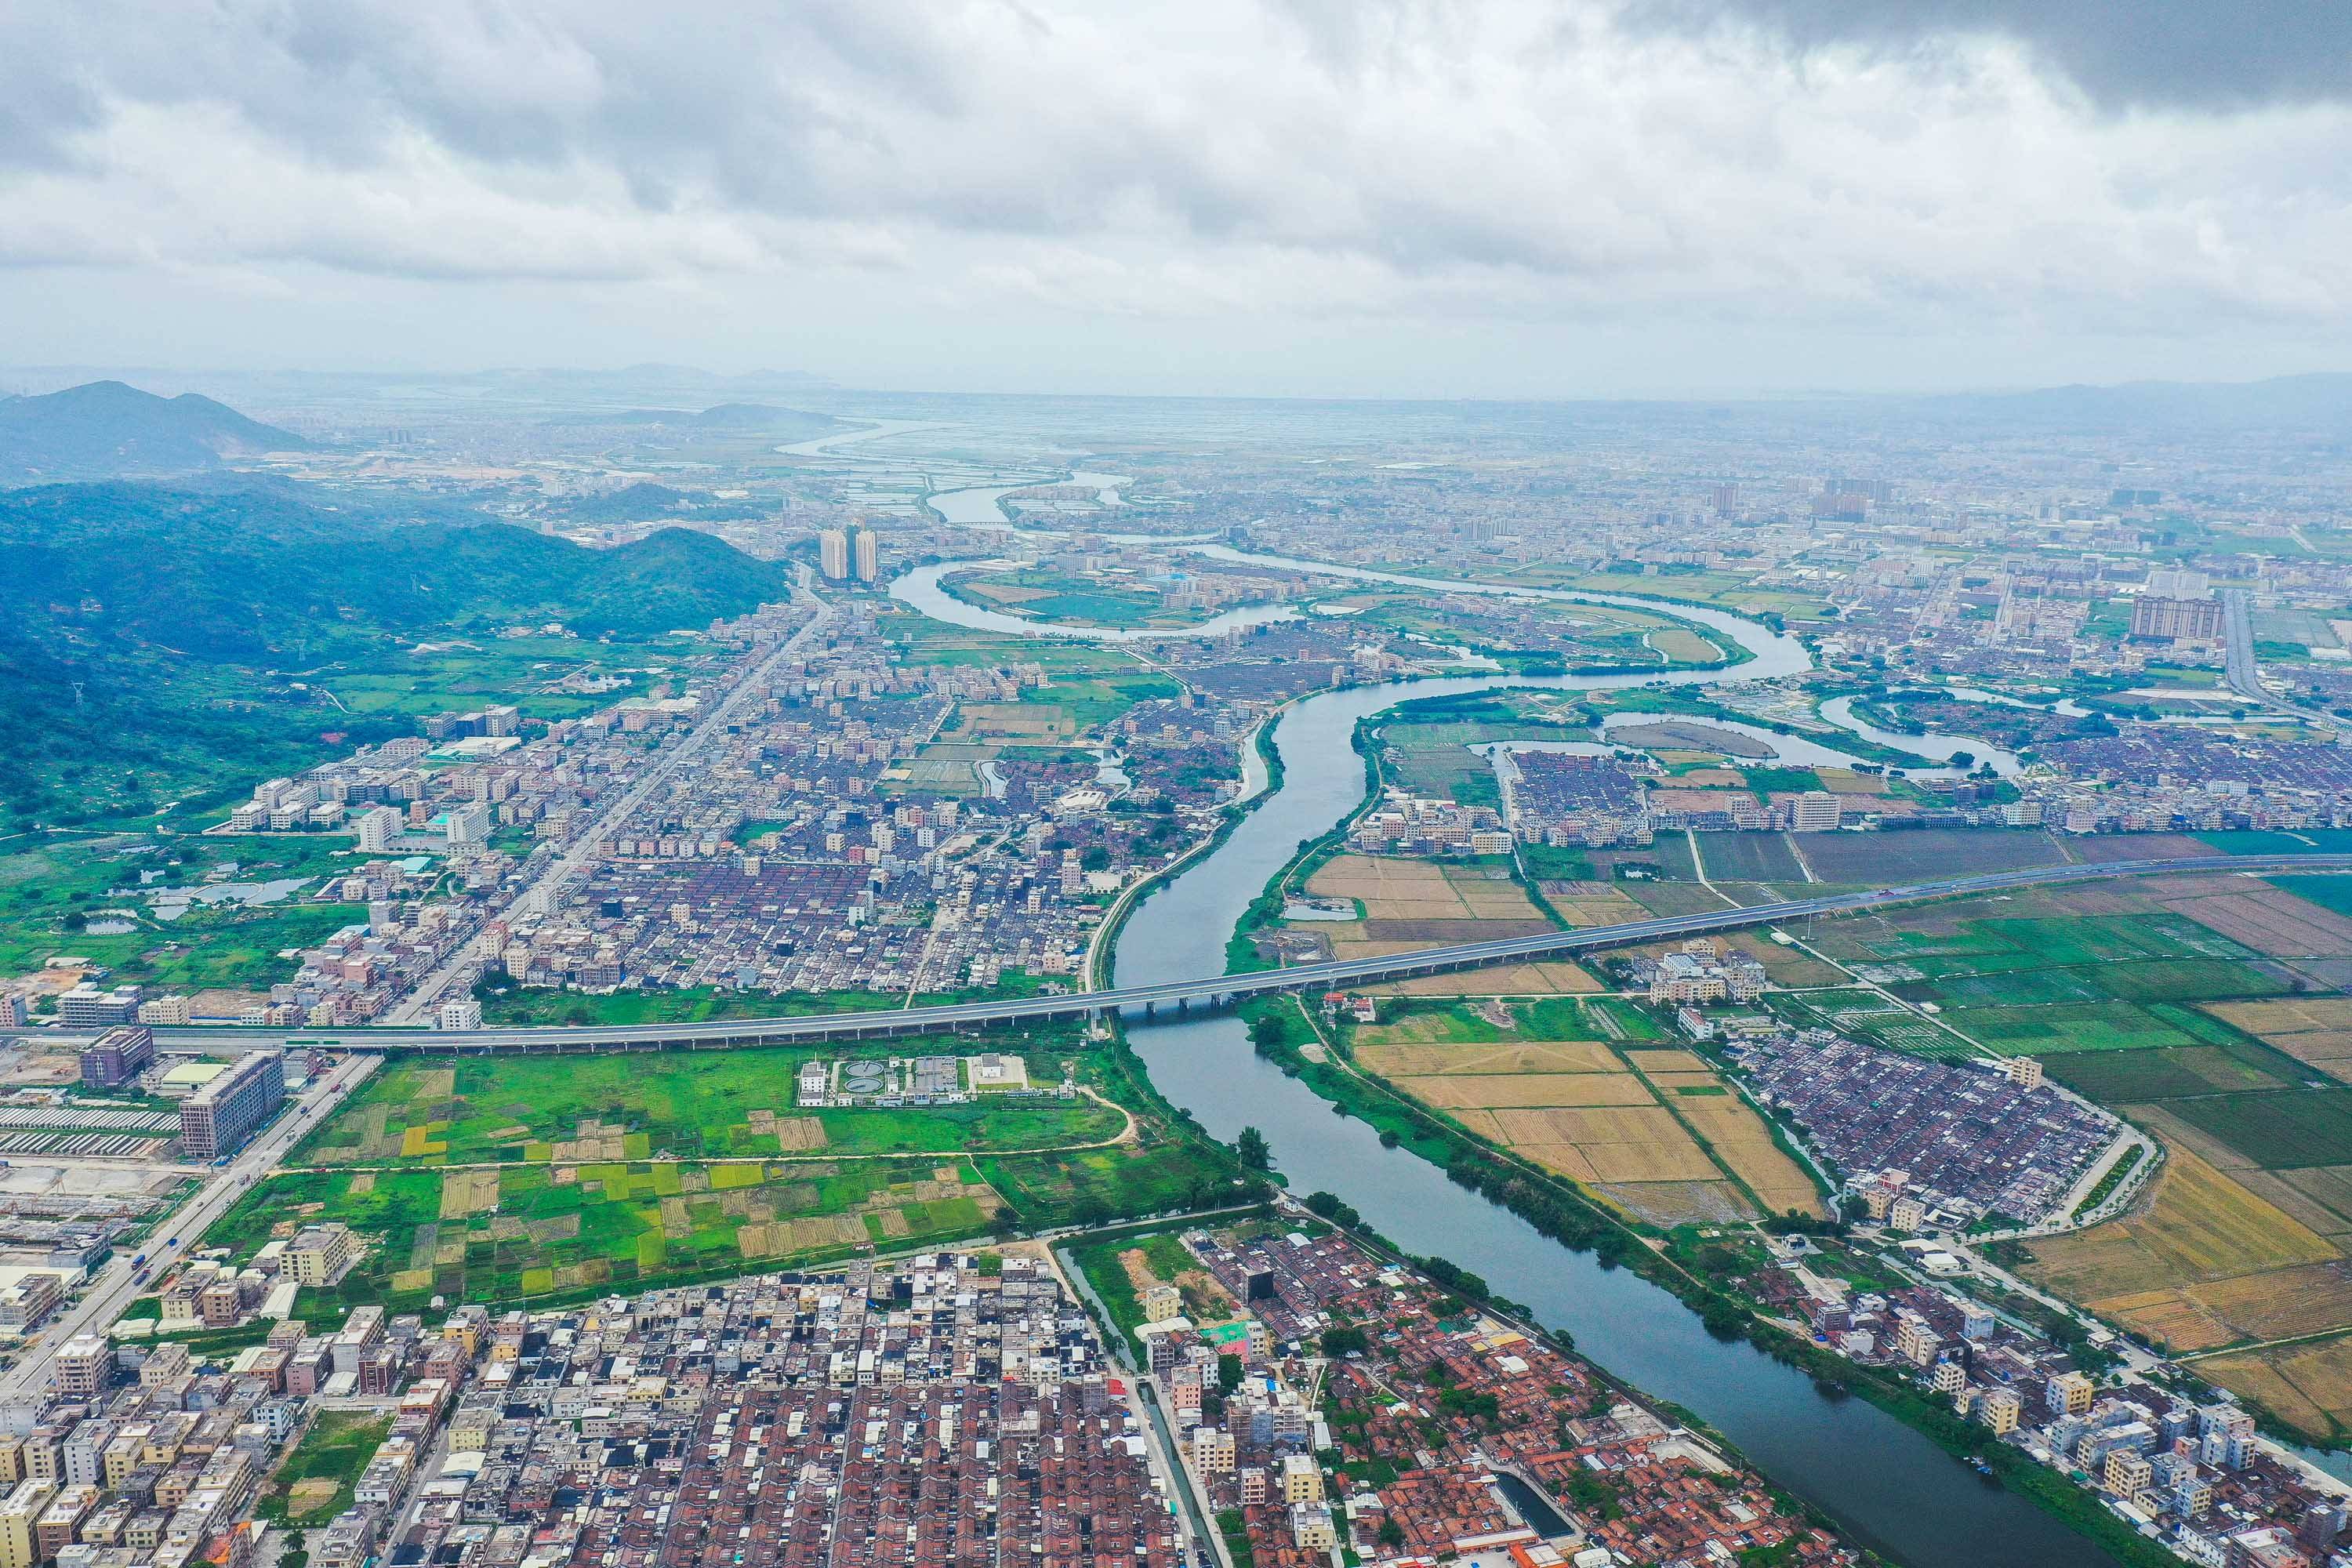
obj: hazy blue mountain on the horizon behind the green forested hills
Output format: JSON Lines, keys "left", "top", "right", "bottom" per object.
{"left": 0, "top": 381, "right": 310, "bottom": 485}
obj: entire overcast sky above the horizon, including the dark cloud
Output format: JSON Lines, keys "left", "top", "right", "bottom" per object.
{"left": 0, "top": 0, "right": 2352, "bottom": 397}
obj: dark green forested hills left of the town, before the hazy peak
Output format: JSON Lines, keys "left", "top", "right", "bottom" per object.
{"left": 0, "top": 485, "right": 786, "bottom": 820}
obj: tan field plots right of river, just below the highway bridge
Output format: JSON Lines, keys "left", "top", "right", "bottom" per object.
{"left": 1350, "top": 1001, "right": 1818, "bottom": 1225}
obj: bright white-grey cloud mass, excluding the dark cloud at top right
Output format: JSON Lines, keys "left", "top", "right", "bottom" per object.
{"left": 0, "top": 0, "right": 2352, "bottom": 359}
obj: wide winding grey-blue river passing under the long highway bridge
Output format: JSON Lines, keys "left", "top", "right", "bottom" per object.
{"left": 894, "top": 481, "right": 2114, "bottom": 1568}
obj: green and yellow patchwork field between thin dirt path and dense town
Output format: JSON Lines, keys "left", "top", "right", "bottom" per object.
{"left": 205, "top": 1159, "right": 1002, "bottom": 1312}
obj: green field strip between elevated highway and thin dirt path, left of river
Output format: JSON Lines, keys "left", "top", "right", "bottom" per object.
{"left": 289, "top": 1039, "right": 1124, "bottom": 1166}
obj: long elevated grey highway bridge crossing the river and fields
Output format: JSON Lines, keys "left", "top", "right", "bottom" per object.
{"left": 155, "top": 855, "right": 2352, "bottom": 1055}
